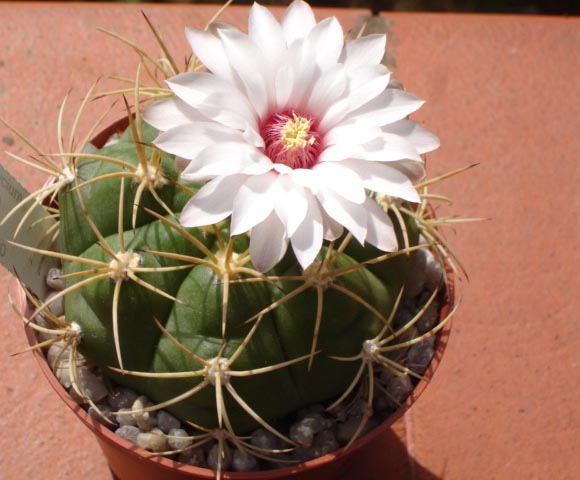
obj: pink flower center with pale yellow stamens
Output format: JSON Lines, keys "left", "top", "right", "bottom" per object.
{"left": 260, "top": 110, "right": 322, "bottom": 168}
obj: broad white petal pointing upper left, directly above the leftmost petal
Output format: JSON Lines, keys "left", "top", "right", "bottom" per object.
{"left": 167, "top": 72, "right": 258, "bottom": 130}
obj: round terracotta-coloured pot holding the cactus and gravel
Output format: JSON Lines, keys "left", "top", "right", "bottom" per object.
{"left": 17, "top": 119, "right": 454, "bottom": 480}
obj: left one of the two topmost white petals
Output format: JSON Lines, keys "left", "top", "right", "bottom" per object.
{"left": 248, "top": 3, "right": 286, "bottom": 64}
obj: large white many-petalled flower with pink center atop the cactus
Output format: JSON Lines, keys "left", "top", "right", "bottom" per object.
{"left": 145, "top": 0, "right": 439, "bottom": 271}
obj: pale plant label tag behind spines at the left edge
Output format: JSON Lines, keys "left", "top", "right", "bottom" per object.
{"left": 0, "top": 165, "right": 59, "bottom": 299}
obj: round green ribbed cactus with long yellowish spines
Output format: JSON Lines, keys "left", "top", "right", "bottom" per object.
{"left": 0, "top": 1, "right": 474, "bottom": 476}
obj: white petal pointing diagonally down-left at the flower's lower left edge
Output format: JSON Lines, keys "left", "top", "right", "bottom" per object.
{"left": 180, "top": 175, "right": 248, "bottom": 227}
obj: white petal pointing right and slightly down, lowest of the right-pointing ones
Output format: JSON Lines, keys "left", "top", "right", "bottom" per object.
{"left": 338, "top": 160, "right": 420, "bottom": 202}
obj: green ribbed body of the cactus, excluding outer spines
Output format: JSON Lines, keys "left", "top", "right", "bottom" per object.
{"left": 59, "top": 122, "right": 417, "bottom": 434}
